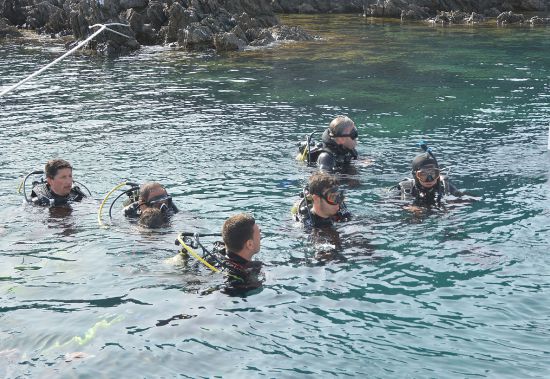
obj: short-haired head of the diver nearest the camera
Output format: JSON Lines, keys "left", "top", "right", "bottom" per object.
{"left": 222, "top": 213, "right": 261, "bottom": 260}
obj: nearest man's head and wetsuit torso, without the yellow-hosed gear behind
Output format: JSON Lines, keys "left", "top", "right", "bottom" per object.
{"left": 222, "top": 213, "right": 262, "bottom": 294}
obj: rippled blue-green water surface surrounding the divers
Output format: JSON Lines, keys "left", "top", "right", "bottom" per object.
{"left": 0, "top": 16, "right": 550, "bottom": 378}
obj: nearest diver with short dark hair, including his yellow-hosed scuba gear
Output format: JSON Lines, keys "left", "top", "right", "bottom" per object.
{"left": 176, "top": 213, "right": 263, "bottom": 295}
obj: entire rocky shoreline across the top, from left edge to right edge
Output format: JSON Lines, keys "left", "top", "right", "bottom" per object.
{"left": 0, "top": 0, "right": 550, "bottom": 56}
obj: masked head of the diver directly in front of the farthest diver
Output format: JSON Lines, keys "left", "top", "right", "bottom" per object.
{"left": 308, "top": 172, "right": 344, "bottom": 218}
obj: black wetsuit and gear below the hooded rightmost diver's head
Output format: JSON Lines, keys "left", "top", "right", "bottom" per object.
{"left": 397, "top": 175, "right": 462, "bottom": 206}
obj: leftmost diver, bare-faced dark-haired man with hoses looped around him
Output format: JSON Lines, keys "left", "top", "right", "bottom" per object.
{"left": 26, "top": 159, "right": 91, "bottom": 206}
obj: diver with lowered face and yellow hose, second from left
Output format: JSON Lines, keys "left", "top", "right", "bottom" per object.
{"left": 123, "top": 182, "right": 178, "bottom": 228}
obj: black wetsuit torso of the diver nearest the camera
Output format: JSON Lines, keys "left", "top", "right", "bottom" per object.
{"left": 223, "top": 251, "right": 262, "bottom": 294}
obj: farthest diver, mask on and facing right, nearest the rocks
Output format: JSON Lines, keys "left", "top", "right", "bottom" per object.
{"left": 296, "top": 116, "right": 359, "bottom": 172}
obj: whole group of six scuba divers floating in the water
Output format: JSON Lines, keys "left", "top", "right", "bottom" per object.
{"left": 21, "top": 116, "right": 470, "bottom": 292}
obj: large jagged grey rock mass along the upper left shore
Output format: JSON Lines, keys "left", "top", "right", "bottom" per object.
{"left": 0, "top": 0, "right": 312, "bottom": 55}
